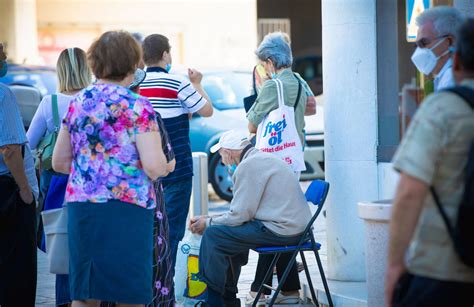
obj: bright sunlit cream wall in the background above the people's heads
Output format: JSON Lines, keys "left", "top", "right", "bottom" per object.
{"left": 36, "top": 0, "right": 257, "bottom": 69}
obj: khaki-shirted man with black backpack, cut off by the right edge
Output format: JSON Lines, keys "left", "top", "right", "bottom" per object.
{"left": 385, "top": 19, "right": 474, "bottom": 307}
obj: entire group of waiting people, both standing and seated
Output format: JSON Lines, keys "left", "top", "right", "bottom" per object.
{"left": 0, "top": 4, "right": 474, "bottom": 307}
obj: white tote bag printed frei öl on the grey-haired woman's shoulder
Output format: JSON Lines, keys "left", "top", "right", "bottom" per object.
{"left": 256, "top": 79, "right": 306, "bottom": 172}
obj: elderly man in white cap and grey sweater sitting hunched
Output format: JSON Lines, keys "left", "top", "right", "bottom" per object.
{"left": 189, "top": 131, "right": 311, "bottom": 307}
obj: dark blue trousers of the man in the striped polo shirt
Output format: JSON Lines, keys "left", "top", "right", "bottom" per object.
{"left": 163, "top": 177, "right": 193, "bottom": 276}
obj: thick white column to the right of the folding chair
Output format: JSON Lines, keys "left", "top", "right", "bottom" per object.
{"left": 322, "top": 0, "right": 380, "bottom": 281}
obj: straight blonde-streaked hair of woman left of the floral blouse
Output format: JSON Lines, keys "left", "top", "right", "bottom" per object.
{"left": 56, "top": 48, "right": 92, "bottom": 93}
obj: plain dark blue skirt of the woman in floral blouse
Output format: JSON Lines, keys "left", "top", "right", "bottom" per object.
{"left": 67, "top": 200, "right": 153, "bottom": 304}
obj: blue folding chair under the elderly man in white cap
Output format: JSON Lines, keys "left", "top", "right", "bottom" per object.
{"left": 252, "top": 180, "right": 334, "bottom": 307}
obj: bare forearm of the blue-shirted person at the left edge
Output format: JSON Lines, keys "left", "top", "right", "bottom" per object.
{"left": 0, "top": 144, "right": 33, "bottom": 204}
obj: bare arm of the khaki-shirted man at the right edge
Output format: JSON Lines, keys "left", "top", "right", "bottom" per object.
{"left": 386, "top": 173, "right": 429, "bottom": 302}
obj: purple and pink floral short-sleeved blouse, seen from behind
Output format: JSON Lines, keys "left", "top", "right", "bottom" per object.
{"left": 63, "top": 83, "right": 158, "bottom": 209}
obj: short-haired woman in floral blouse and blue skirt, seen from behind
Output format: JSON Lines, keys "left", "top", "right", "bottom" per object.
{"left": 53, "top": 31, "right": 167, "bottom": 306}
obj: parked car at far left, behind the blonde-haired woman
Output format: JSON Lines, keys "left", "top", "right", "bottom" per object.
{"left": 0, "top": 64, "right": 57, "bottom": 128}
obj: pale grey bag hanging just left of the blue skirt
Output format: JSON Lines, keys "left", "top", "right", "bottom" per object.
{"left": 41, "top": 206, "right": 69, "bottom": 274}
